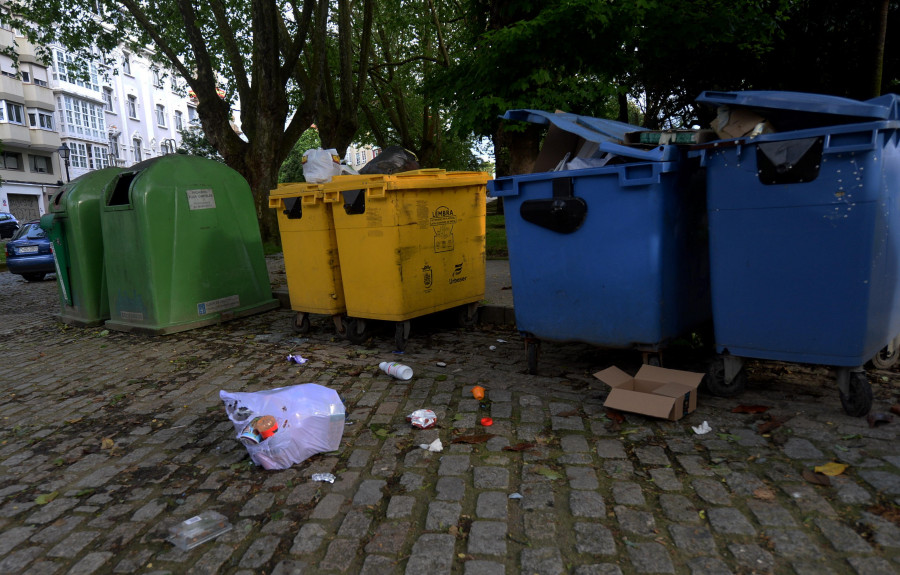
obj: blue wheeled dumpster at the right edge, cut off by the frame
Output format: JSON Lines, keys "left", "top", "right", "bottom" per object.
{"left": 697, "top": 92, "right": 900, "bottom": 415}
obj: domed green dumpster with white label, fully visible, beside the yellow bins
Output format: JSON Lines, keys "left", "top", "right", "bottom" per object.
{"left": 100, "top": 154, "right": 279, "bottom": 334}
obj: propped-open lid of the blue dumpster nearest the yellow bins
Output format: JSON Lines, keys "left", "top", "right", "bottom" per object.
{"left": 500, "top": 109, "right": 677, "bottom": 162}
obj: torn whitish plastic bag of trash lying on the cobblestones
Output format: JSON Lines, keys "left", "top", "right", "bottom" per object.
{"left": 219, "top": 383, "right": 345, "bottom": 469}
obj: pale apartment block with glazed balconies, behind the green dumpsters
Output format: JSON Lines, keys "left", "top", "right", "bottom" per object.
{"left": 0, "top": 24, "right": 197, "bottom": 221}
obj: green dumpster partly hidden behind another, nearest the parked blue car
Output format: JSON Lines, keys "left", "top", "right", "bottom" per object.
{"left": 41, "top": 168, "right": 122, "bottom": 326}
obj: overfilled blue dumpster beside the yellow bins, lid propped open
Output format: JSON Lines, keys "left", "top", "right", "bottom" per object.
{"left": 488, "top": 110, "right": 710, "bottom": 373}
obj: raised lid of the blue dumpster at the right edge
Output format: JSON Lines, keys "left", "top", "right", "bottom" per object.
{"left": 697, "top": 90, "right": 900, "bottom": 132}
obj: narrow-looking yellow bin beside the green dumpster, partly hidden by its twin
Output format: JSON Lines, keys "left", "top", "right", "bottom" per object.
{"left": 269, "top": 183, "right": 346, "bottom": 333}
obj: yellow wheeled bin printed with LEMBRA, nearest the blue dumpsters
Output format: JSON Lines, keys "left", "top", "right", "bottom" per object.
{"left": 323, "top": 169, "right": 490, "bottom": 350}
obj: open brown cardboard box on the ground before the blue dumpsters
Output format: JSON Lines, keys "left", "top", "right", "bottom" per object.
{"left": 594, "top": 365, "right": 703, "bottom": 421}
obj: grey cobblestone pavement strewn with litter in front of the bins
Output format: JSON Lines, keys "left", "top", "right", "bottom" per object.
{"left": 0, "top": 271, "right": 900, "bottom": 575}
